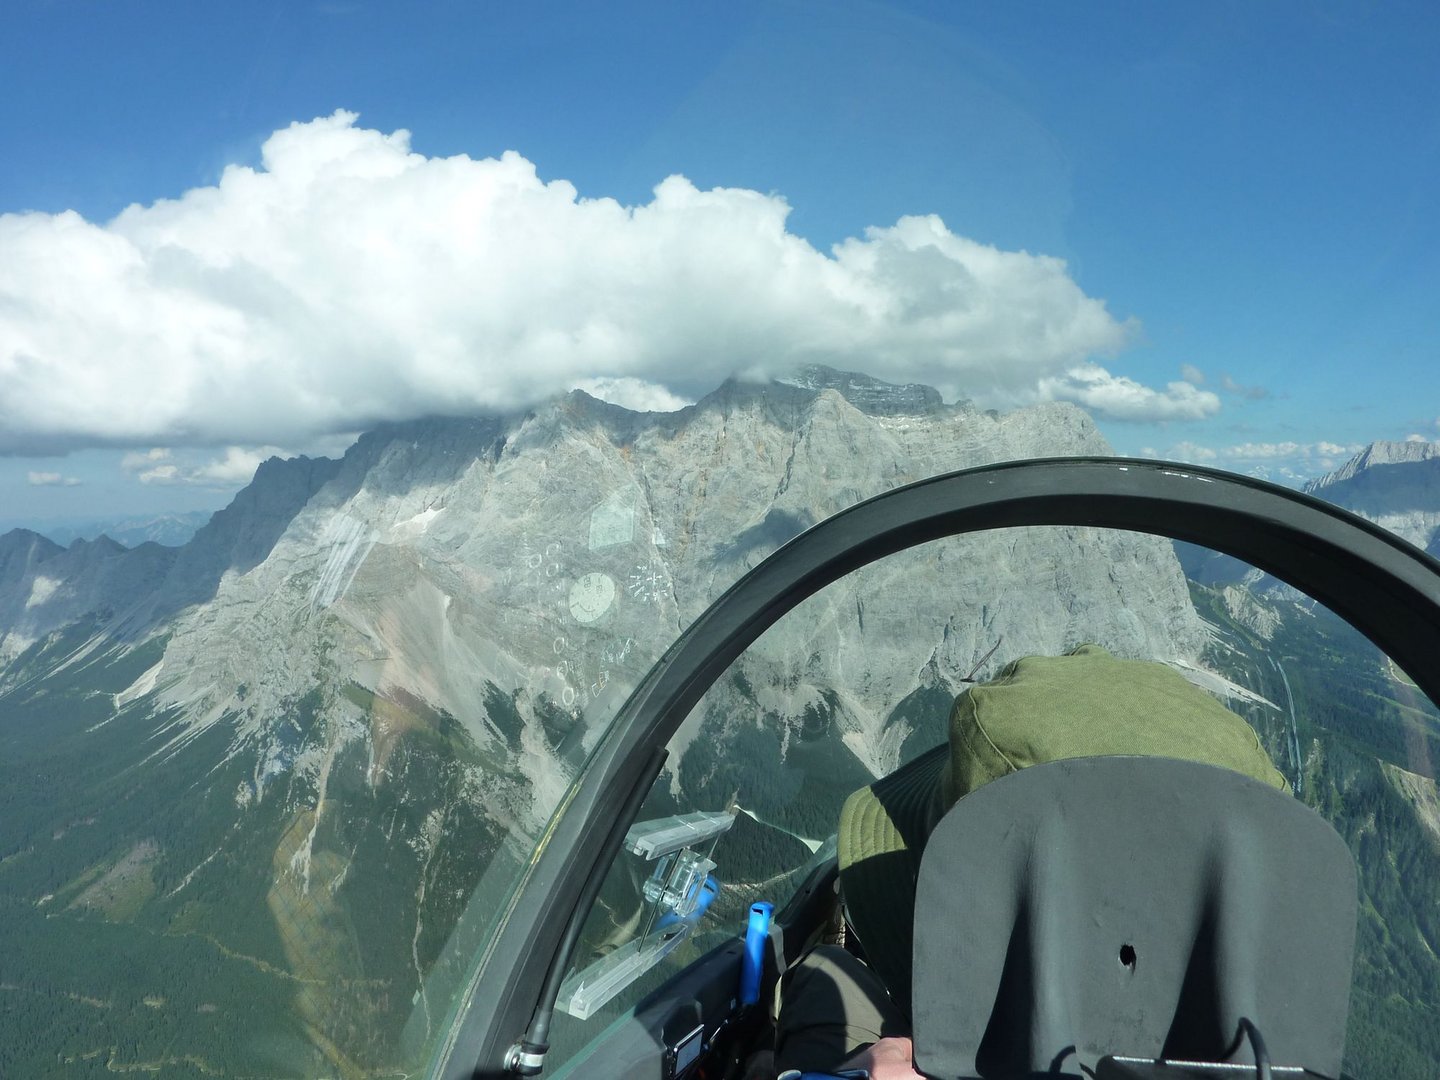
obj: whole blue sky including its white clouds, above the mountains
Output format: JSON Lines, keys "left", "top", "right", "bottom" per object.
{"left": 0, "top": 0, "right": 1440, "bottom": 538}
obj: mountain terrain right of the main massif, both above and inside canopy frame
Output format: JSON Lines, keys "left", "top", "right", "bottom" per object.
{"left": 1176, "top": 442, "right": 1440, "bottom": 1077}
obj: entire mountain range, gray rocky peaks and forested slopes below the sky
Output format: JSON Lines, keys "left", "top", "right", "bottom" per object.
{"left": 0, "top": 367, "right": 1440, "bottom": 1076}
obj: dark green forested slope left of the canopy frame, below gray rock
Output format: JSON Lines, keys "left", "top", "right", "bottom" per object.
{"left": 0, "top": 628, "right": 505, "bottom": 1077}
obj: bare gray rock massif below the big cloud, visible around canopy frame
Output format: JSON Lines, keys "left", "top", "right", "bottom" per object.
{"left": 0, "top": 367, "right": 1205, "bottom": 806}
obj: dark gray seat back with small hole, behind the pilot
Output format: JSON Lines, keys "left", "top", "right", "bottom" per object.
{"left": 912, "top": 757, "right": 1356, "bottom": 1080}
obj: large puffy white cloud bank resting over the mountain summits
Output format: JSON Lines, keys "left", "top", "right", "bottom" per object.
{"left": 0, "top": 112, "right": 1192, "bottom": 452}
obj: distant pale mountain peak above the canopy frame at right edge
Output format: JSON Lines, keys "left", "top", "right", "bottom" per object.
{"left": 1305, "top": 442, "right": 1440, "bottom": 554}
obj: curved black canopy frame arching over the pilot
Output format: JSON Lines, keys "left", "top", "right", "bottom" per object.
{"left": 436, "top": 458, "right": 1440, "bottom": 1079}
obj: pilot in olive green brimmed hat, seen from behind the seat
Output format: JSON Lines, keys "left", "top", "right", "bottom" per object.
{"left": 775, "top": 645, "right": 1289, "bottom": 1080}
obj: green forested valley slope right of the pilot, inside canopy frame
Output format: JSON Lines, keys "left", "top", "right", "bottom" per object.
{"left": 1192, "top": 586, "right": 1440, "bottom": 1080}
